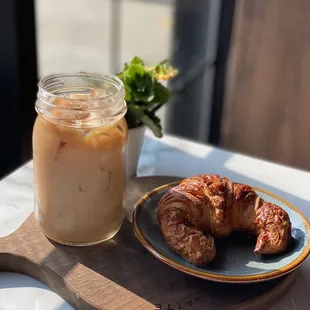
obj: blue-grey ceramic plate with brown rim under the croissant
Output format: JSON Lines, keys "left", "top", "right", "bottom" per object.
{"left": 133, "top": 183, "right": 310, "bottom": 283}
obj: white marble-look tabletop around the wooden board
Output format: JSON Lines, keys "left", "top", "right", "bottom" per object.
{"left": 0, "top": 131, "right": 310, "bottom": 310}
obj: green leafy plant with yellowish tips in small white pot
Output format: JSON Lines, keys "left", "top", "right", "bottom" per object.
{"left": 117, "top": 57, "right": 177, "bottom": 177}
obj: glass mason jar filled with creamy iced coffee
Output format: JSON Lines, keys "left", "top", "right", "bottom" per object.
{"left": 33, "top": 73, "right": 127, "bottom": 246}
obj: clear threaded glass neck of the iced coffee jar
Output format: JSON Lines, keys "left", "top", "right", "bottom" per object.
{"left": 36, "top": 73, "right": 127, "bottom": 127}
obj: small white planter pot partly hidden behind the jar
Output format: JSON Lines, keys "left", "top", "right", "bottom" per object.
{"left": 127, "top": 126, "right": 146, "bottom": 178}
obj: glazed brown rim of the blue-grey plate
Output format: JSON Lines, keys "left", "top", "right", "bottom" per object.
{"left": 132, "top": 180, "right": 310, "bottom": 283}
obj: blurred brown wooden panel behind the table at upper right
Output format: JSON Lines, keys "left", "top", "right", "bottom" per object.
{"left": 220, "top": 0, "right": 310, "bottom": 170}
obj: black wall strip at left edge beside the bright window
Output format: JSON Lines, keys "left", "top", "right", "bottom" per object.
{"left": 0, "top": 0, "right": 37, "bottom": 178}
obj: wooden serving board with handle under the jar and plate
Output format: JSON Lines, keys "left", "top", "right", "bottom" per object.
{"left": 0, "top": 177, "right": 296, "bottom": 310}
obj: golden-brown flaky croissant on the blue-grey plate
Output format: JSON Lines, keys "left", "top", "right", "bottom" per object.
{"left": 157, "top": 174, "right": 291, "bottom": 266}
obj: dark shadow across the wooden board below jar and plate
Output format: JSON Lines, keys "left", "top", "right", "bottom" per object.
{"left": 42, "top": 220, "right": 298, "bottom": 310}
